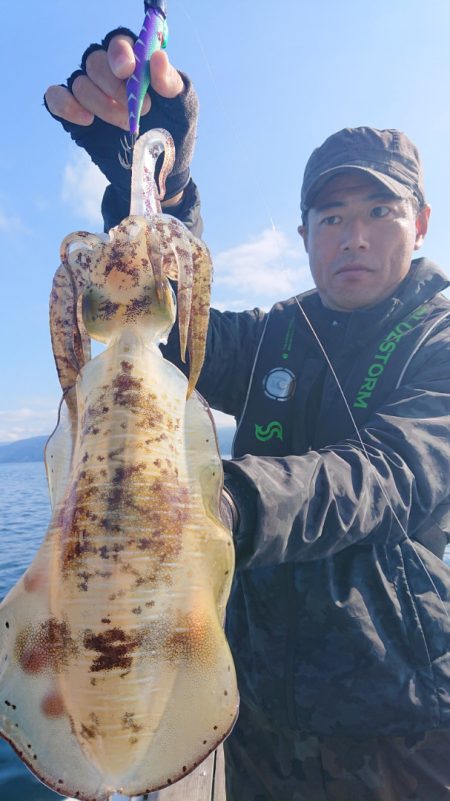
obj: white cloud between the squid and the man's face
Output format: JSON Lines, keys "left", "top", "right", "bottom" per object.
{"left": 213, "top": 228, "right": 311, "bottom": 310}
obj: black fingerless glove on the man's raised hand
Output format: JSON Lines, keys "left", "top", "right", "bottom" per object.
{"left": 44, "top": 28, "right": 198, "bottom": 227}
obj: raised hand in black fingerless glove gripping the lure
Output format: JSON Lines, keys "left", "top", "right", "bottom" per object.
{"left": 45, "top": 28, "right": 202, "bottom": 231}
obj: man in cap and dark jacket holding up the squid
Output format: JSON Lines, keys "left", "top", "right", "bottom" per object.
{"left": 46, "top": 30, "right": 450, "bottom": 801}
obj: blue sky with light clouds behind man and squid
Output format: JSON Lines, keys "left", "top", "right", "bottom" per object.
{"left": 0, "top": 0, "right": 450, "bottom": 442}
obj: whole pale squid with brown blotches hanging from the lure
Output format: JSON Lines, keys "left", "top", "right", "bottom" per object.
{"left": 0, "top": 131, "right": 238, "bottom": 801}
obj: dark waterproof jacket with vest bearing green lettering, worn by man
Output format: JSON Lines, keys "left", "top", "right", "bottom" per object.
{"left": 106, "top": 183, "right": 450, "bottom": 737}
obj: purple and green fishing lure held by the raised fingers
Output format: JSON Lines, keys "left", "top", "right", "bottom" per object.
{"left": 119, "top": 0, "right": 168, "bottom": 169}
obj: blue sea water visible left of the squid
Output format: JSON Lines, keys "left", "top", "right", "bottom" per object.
{"left": 0, "top": 462, "right": 450, "bottom": 801}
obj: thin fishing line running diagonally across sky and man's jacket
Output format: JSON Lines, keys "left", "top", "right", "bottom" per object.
{"left": 171, "top": 4, "right": 450, "bottom": 617}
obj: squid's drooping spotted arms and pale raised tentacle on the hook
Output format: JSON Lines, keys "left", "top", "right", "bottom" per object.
{"left": 50, "top": 129, "right": 212, "bottom": 400}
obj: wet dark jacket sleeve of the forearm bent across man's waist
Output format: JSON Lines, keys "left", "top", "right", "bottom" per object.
{"left": 225, "top": 322, "right": 450, "bottom": 569}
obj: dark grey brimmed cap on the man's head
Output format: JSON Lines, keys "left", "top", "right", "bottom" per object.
{"left": 300, "top": 127, "right": 425, "bottom": 215}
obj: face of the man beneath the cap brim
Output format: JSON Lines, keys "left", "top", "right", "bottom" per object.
{"left": 298, "top": 171, "right": 430, "bottom": 311}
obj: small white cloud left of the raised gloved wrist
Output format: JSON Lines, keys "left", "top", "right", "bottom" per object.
{"left": 61, "top": 150, "right": 107, "bottom": 231}
